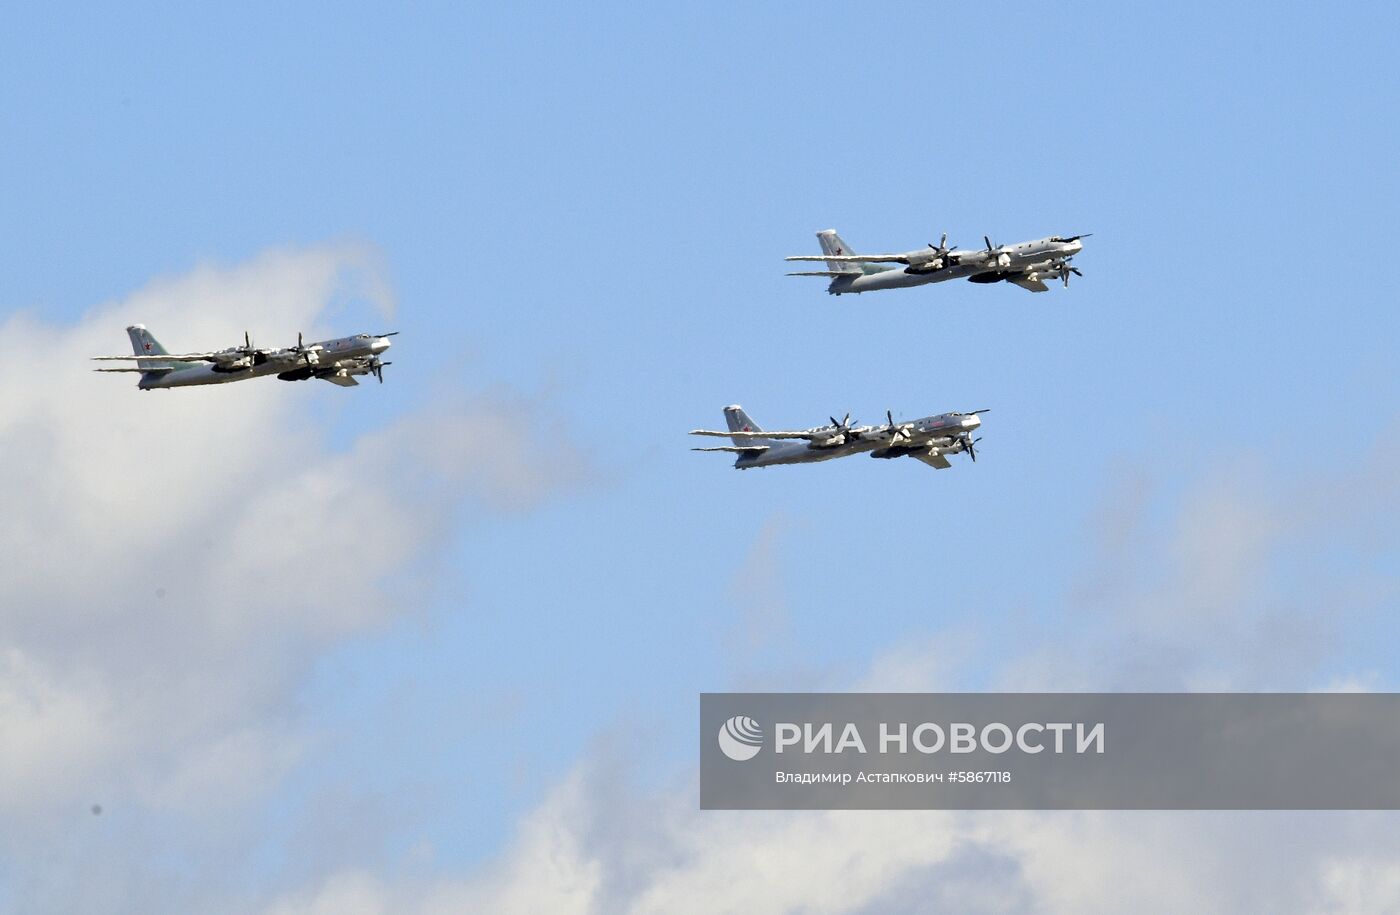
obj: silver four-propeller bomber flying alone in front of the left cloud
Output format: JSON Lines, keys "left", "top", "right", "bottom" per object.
{"left": 92, "top": 325, "right": 398, "bottom": 390}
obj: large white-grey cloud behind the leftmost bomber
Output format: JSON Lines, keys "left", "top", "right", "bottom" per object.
{"left": 0, "top": 245, "right": 588, "bottom": 911}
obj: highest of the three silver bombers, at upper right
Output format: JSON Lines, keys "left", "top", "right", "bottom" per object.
{"left": 787, "top": 229, "right": 1089, "bottom": 295}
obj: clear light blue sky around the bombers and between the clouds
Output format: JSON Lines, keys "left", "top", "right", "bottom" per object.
{"left": 0, "top": 3, "right": 1400, "bottom": 900}
